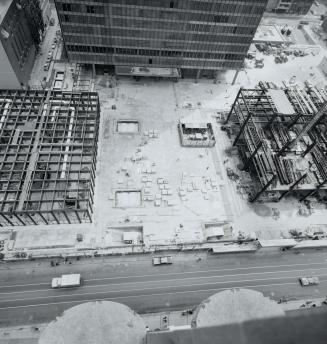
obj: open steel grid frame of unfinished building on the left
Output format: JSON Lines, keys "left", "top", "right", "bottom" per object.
{"left": 0, "top": 90, "right": 99, "bottom": 226}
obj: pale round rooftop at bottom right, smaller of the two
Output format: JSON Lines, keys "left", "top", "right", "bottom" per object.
{"left": 192, "top": 289, "right": 285, "bottom": 327}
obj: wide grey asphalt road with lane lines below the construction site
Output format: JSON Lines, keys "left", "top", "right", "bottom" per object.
{"left": 0, "top": 251, "right": 327, "bottom": 326}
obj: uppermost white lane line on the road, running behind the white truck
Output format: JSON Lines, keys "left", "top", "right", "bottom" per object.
{"left": 0, "top": 261, "right": 327, "bottom": 290}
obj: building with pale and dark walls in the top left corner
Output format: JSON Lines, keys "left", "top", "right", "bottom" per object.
{"left": 0, "top": 0, "right": 36, "bottom": 89}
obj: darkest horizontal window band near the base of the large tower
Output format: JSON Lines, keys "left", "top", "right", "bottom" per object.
{"left": 66, "top": 45, "right": 244, "bottom": 61}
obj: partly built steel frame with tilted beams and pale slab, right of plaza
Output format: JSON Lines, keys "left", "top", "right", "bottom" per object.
{"left": 227, "top": 84, "right": 327, "bottom": 202}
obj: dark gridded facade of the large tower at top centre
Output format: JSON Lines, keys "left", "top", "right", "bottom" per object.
{"left": 55, "top": 0, "right": 267, "bottom": 77}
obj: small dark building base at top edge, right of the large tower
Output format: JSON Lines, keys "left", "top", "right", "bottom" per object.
{"left": 267, "top": 0, "right": 314, "bottom": 15}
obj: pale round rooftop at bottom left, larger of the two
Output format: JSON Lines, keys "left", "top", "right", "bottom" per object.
{"left": 39, "top": 301, "right": 146, "bottom": 344}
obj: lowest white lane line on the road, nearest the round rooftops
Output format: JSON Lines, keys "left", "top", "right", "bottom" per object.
{"left": 0, "top": 281, "right": 327, "bottom": 310}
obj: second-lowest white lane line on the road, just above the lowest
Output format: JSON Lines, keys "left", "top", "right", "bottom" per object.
{"left": 0, "top": 275, "right": 327, "bottom": 309}
